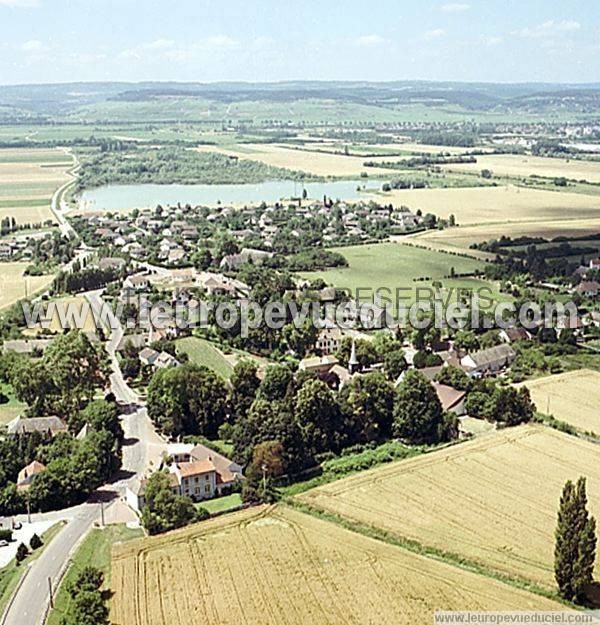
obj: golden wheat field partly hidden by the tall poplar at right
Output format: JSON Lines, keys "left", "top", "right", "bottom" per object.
{"left": 299, "top": 426, "right": 600, "bottom": 587}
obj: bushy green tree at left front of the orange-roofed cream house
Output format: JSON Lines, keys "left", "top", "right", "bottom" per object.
{"left": 142, "top": 471, "right": 196, "bottom": 535}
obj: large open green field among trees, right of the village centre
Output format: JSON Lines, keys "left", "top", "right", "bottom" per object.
{"left": 301, "top": 243, "right": 498, "bottom": 302}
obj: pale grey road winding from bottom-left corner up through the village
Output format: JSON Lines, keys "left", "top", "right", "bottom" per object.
{"left": 0, "top": 291, "right": 165, "bottom": 625}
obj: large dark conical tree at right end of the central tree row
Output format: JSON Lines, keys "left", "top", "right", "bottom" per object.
{"left": 393, "top": 369, "right": 444, "bottom": 444}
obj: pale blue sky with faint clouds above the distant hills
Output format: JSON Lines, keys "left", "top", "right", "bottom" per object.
{"left": 0, "top": 0, "right": 600, "bottom": 84}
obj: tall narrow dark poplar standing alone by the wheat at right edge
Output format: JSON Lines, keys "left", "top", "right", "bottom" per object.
{"left": 554, "top": 477, "right": 596, "bottom": 602}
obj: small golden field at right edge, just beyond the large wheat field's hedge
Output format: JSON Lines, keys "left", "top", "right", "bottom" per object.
{"left": 519, "top": 369, "right": 600, "bottom": 434}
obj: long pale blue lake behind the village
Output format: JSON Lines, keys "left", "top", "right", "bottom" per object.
{"left": 80, "top": 179, "right": 382, "bottom": 211}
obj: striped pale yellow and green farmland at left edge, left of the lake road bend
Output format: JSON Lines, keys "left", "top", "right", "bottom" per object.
{"left": 0, "top": 148, "right": 73, "bottom": 224}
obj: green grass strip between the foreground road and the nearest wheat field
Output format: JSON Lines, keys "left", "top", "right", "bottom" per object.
{"left": 47, "top": 525, "right": 143, "bottom": 625}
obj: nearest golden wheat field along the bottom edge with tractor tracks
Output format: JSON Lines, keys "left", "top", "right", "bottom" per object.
{"left": 111, "top": 508, "right": 559, "bottom": 625}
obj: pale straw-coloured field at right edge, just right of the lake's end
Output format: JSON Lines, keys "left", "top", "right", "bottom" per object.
{"left": 366, "top": 185, "right": 600, "bottom": 225}
